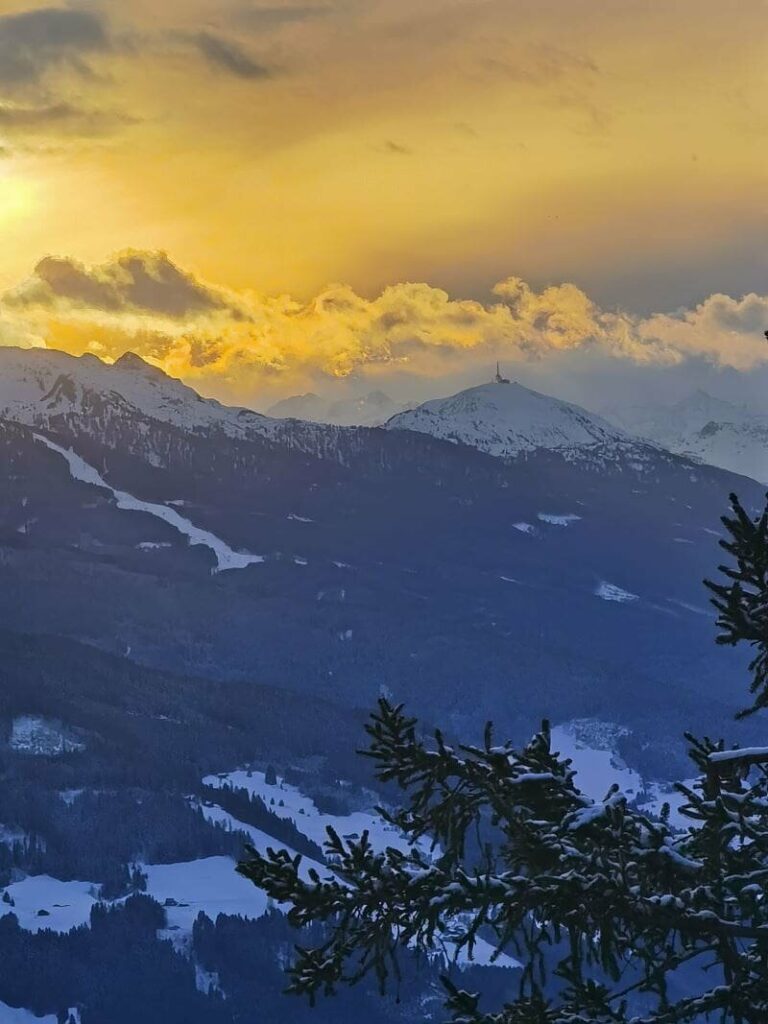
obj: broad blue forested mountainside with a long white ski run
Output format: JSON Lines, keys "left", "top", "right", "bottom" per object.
{"left": 0, "top": 349, "right": 762, "bottom": 772}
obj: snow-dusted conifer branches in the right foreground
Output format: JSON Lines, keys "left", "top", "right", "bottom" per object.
{"left": 239, "top": 497, "right": 768, "bottom": 1024}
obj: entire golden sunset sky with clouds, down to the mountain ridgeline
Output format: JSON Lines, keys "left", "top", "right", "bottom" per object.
{"left": 0, "top": 0, "right": 768, "bottom": 408}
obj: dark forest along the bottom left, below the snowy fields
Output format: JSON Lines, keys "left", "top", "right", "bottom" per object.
{"left": 0, "top": 895, "right": 448, "bottom": 1024}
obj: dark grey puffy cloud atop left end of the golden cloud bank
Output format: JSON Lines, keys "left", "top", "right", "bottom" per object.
{"left": 5, "top": 251, "right": 237, "bottom": 317}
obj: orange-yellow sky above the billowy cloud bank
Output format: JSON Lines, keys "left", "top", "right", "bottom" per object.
{"left": 0, "top": 0, "right": 768, "bottom": 399}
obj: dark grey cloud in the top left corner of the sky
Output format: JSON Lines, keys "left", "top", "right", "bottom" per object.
{"left": 0, "top": 7, "right": 110, "bottom": 87}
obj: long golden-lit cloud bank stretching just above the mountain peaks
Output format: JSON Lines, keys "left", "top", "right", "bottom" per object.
{"left": 0, "top": 251, "right": 768, "bottom": 402}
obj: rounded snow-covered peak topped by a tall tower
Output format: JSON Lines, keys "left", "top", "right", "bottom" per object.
{"left": 386, "top": 382, "right": 632, "bottom": 459}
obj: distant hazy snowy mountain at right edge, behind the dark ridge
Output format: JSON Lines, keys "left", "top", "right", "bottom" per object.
{"left": 606, "top": 391, "right": 768, "bottom": 483}
